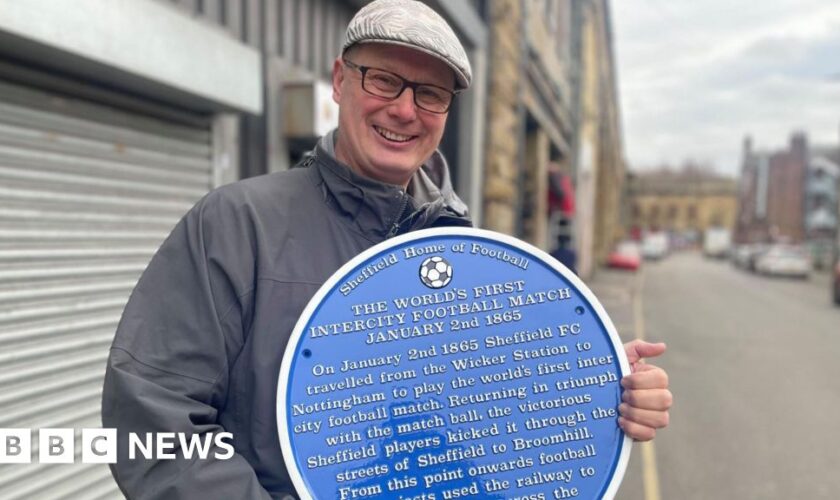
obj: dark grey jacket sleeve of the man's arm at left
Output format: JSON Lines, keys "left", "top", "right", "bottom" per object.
{"left": 102, "top": 193, "right": 270, "bottom": 500}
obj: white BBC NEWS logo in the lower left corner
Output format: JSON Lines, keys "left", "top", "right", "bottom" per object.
{"left": 0, "top": 428, "right": 234, "bottom": 464}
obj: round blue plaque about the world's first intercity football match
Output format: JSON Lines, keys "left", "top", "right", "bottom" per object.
{"left": 277, "top": 228, "right": 631, "bottom": 500}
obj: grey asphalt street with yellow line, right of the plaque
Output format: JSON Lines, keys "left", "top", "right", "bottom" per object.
{"left": 593, "top": 253, "right": 840, "bottom": 500}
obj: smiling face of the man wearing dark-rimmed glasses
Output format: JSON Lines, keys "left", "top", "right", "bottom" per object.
{"left": 333, "top": 43, "right": 455, "bottom": 186}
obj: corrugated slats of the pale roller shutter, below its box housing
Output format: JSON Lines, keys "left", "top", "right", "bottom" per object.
{"left": 0, "top": 80, "right": 213, "bottom": 500}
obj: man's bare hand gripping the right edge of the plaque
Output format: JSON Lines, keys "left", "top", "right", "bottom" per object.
{"left": 618, "top": 340, "right": 673, "bottom": 441}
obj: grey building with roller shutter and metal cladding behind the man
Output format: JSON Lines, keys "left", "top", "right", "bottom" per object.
{"left": 0, "top": 0, "right": 488, "bottom": 499}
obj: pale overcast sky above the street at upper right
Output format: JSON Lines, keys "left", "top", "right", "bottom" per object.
{"left": 611, "top": 0, "right": 840, "bottom": 175}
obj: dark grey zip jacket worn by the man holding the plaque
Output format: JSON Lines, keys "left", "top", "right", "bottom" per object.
{"left": 102, "top": 136, "right": 470, "bottom": 500}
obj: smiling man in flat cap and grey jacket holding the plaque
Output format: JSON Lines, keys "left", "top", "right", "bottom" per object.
{"left": 102, "top": 0, "right": 670, "bottom": 500}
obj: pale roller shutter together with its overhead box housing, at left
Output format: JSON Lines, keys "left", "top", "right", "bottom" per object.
{"left": 0, "top": 0, "right": 264, "bottom": 499}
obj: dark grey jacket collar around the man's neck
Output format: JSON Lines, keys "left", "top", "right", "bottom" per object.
{"left": 312, "top": 131, "right": 469, "bottom": 240}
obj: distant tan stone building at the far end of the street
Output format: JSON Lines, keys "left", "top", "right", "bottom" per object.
{"left": 627, "top": 170, "right": 737, "bottom": 235}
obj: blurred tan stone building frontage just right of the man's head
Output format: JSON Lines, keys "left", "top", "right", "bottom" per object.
{"left": 484, "top": 0, "right": 624, "bottom": 277}
